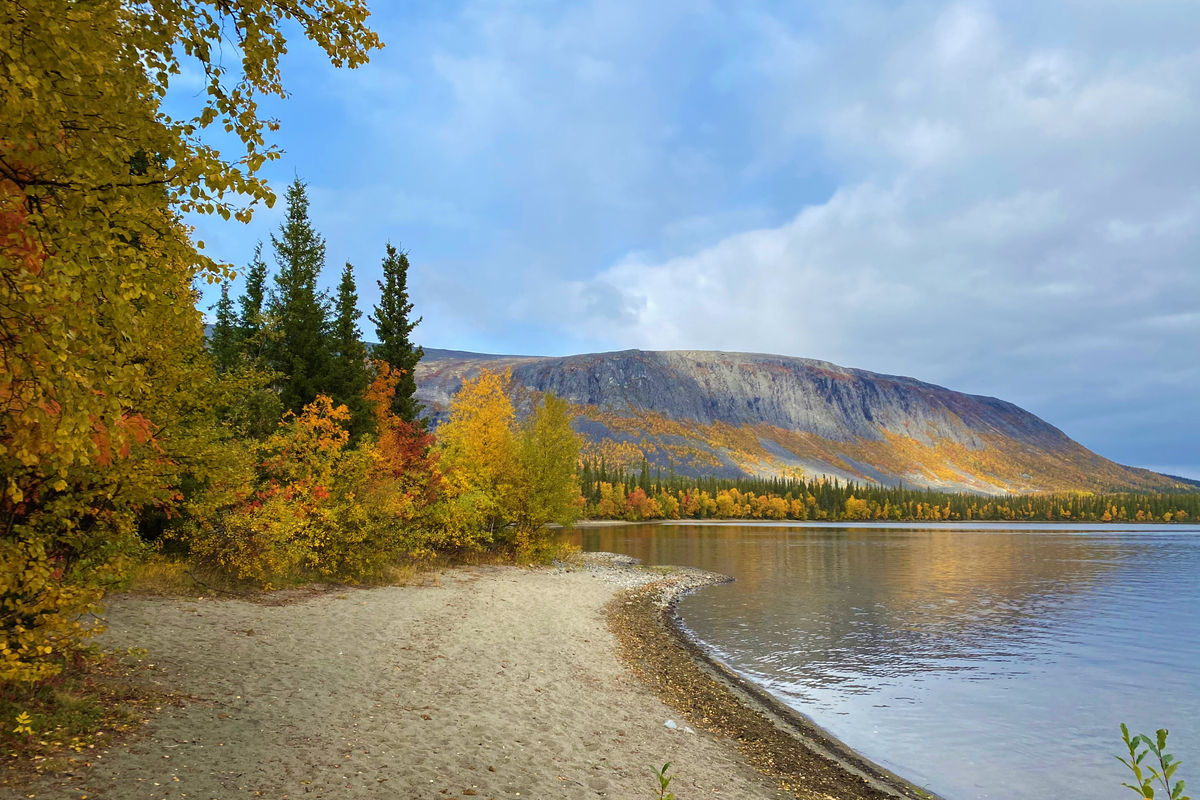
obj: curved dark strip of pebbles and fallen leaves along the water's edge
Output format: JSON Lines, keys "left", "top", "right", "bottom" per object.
{"left": 604, "top": 554, "right": 941, "bottom": 800}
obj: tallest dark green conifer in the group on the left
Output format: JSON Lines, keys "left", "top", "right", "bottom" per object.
{"left": 266, "top": 178, "right": 331, "bottom": 413}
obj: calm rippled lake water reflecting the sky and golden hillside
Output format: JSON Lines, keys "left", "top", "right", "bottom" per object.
{"left": 574, "top": 523, "right": 1200, "bottom": 800}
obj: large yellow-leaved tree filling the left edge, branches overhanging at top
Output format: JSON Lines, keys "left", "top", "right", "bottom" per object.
{"left": 0, "top": 0, "right": 379, "bottom": 681}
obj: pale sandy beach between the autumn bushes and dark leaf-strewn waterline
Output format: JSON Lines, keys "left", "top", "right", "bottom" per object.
{"left": 14, "top": 560, "right": 916, "bottom": 800}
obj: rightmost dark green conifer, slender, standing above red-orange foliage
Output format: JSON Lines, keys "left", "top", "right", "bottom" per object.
{"left": 370, "top": 242, "right": 425, "bottom": 422}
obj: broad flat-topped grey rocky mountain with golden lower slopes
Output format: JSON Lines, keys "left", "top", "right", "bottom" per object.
{"left": 416, "top": 349, "right": 1178, "bottom": 492}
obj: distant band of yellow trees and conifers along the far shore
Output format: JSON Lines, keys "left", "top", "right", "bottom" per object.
{"left": 580, "top": 461, "right": 1200, "bottom": 522}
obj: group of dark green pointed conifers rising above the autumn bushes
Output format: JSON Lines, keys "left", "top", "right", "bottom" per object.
{"left": 208, "top": 178, "right": 424, "bottom": 441}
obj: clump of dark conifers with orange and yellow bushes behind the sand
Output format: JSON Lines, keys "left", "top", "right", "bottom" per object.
{"left": 174, "top": 179, "right": 580, "bottom": 585}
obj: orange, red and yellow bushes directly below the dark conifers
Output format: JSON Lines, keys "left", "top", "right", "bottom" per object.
{"left": 184, "top": 363, "right": 451, "bottom": 587}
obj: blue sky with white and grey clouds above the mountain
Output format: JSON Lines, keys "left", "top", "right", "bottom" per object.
{"left": 180, "top": 0, "right": 1200, "bottom": 477}
